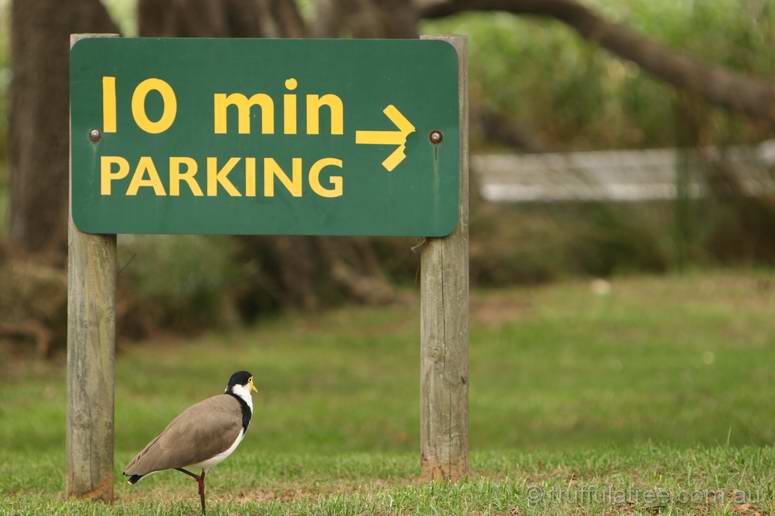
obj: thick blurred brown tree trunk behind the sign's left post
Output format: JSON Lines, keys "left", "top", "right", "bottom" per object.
{"left": 10, "top": 0, "right": 118, "bottom": 265}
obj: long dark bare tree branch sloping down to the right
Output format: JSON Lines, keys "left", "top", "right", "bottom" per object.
{"left": 420, "top": 0, "right": 775, "bottom": 126}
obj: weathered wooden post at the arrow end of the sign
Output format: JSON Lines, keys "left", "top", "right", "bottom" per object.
{"left": 420, "top": 36, "right": 468, "bottom": 479}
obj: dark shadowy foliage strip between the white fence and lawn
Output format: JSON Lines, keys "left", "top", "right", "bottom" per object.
{"left": 470, "top": 185, "right": 775, "bottom": 287}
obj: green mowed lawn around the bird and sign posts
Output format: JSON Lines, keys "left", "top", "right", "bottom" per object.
{"left": 0, "top": 271, "right": 775, "bottom": 514}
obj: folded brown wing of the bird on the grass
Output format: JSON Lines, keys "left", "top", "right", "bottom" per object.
{"left": 124, "top": 394, "right": 242, "bottom": 476}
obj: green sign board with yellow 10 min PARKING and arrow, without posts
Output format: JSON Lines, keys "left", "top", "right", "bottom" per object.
{"left": 70, "top": 38, "right": 460, "bottom": 236}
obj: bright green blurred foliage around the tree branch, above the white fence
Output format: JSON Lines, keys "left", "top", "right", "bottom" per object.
{"left": 424, "top": 0, "right": 775, "bottom": 150}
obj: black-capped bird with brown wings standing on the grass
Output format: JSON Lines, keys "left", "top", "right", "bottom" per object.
{"left": 123, "top": 371, "right": 257, "bottom": 514}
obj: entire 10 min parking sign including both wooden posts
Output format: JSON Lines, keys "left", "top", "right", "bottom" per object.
{"left": 66, "top": 35, "right": 468, "bottom": 500}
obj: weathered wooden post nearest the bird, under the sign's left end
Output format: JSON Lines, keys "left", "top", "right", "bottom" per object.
{"left": 66, "top": 34, "right": 118, "bottom": 500}
